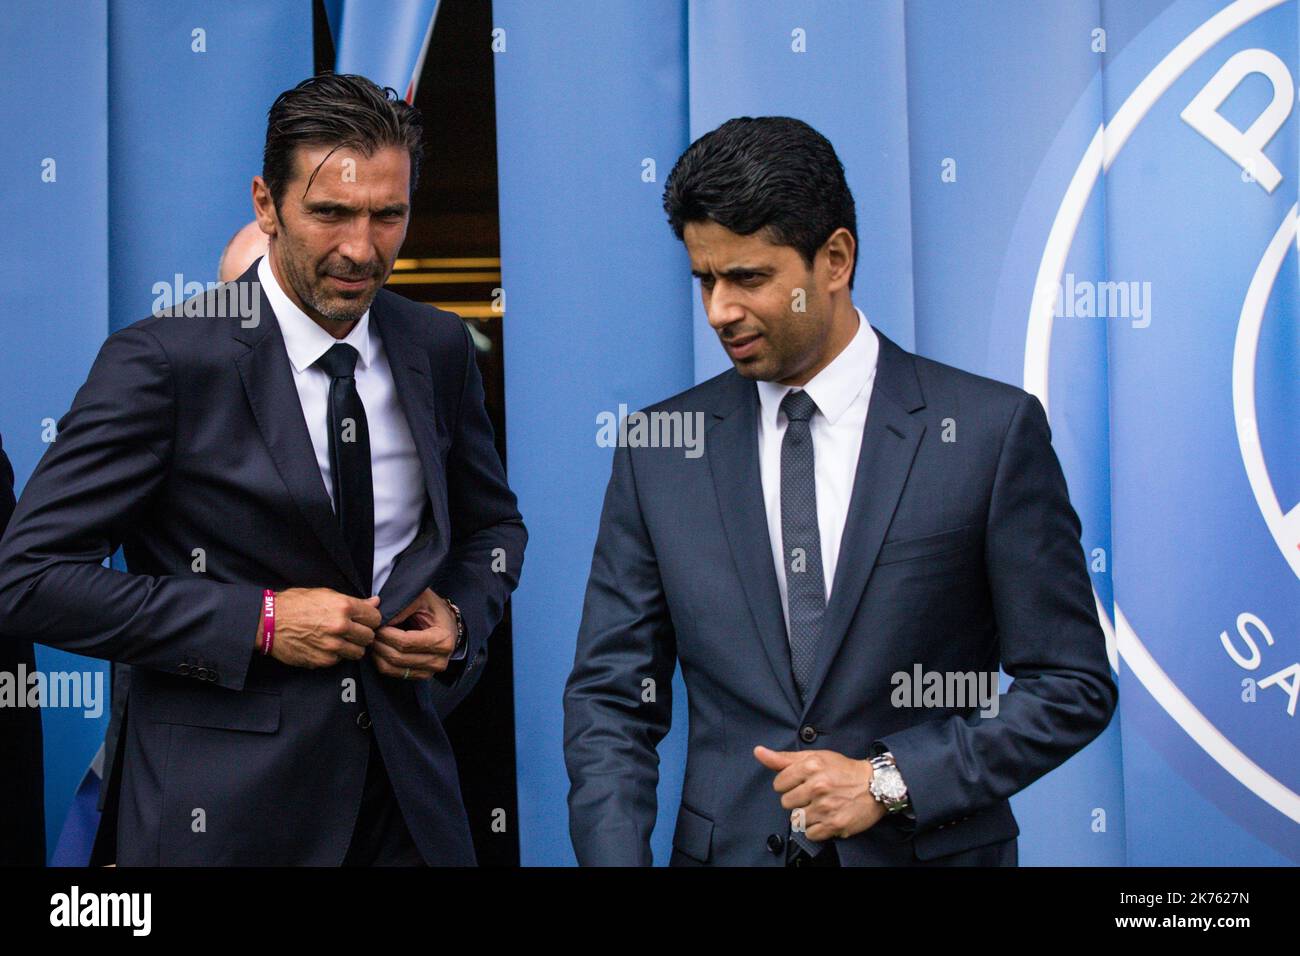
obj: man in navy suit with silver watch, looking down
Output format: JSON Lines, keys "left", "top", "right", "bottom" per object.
{"left": 564, "top": 117, "right": 1117, "bottom": 866}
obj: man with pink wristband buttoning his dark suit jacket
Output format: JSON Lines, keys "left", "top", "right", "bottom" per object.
{"left": 0, "top": 74, "right": 527, "bottom": 865}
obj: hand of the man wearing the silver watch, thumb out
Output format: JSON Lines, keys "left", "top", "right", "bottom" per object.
{"left": 754, "top": 747, "right": 888, "bottom": 842}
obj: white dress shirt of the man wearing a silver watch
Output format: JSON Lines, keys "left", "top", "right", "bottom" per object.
{"left": 758, "top": 308, "right": 880, "bottom": 635}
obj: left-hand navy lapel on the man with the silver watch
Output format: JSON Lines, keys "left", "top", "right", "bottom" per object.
{"left": 705, "top": 375, "right": 800, "bottom": 713}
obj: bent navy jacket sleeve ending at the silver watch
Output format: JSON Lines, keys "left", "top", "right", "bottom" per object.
{"left": 872, "top": 394, "right": 1117, "bottom": 832}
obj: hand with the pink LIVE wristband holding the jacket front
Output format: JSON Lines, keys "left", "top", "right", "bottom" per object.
{"left": 257, "top": 588, "right": 382, "bottom": 667}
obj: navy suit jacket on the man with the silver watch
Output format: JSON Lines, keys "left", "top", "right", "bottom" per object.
{"left": 564, "top": 327, "right": 1117, "bottom": 865}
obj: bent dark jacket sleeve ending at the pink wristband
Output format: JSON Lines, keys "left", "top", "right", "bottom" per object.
{"left": 0, "top": 326, "right": 261, "bottom": 689}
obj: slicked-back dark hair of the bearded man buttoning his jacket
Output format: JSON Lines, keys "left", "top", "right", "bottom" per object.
{"left": 261, "top": 73, "right": 424, "bottom": 211}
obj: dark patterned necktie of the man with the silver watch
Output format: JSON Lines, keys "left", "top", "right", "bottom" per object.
{"left": 781, "top": 390, "right": 826, "bottom": 856}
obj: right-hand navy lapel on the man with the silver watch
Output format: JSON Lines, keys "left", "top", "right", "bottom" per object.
{"left": 805, "top": 332, "right": 926, "bottom": 710}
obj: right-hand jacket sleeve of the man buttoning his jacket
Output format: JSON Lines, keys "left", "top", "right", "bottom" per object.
{"left": 430, "top": 321, "right": 528, "bottom": 713}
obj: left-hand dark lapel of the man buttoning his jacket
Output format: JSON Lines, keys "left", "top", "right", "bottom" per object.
{"left": 234, "top": 269, "right": 371, "bottom": 596}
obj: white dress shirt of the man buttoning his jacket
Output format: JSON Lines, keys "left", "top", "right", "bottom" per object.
{"left": 257, "top": 256, "right": 425, "bottom": 594}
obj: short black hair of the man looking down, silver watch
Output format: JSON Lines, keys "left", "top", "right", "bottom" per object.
{"left": 663, "top": 116, "right": 858, "bottom": 289}
